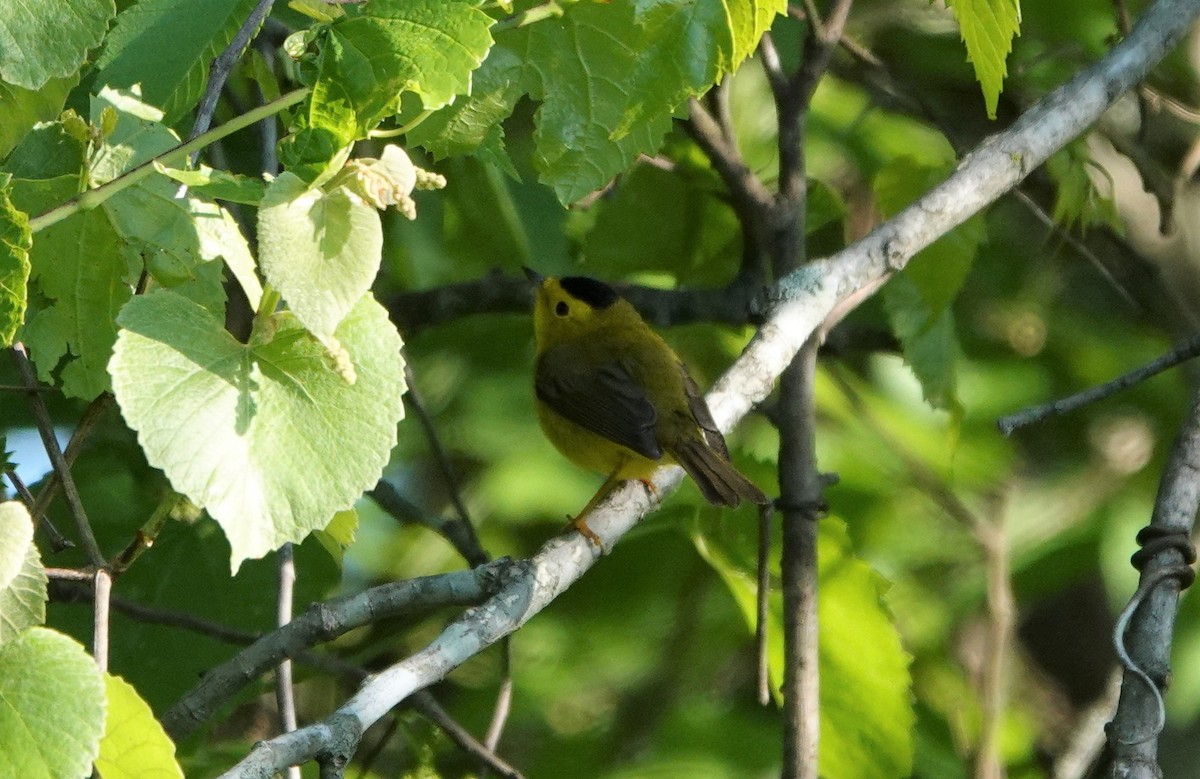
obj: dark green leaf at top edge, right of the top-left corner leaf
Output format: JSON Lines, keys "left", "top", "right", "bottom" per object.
{"left": 97, "top": 0, "right": 267, "bottom": 125}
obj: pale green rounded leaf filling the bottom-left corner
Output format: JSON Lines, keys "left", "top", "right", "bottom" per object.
{"left": 0, "top": 628, "right": 104, "bottom": 777}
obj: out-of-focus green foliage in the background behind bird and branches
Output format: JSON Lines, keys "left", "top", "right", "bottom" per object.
{"left": 0, "top": 0, "right": 1200, "bottom": 779}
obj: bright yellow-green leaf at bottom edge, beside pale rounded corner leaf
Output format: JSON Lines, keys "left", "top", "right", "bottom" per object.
{"left": 96, "top": 673, "right": 184, "bottom": 779}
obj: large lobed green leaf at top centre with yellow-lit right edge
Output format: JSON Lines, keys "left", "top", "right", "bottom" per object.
{"left": 415, "top": 0, "right": 786, "bottom": 203}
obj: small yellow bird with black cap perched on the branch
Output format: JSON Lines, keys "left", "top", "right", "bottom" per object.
{"left": 524, "top": 268, "right": 770, "bottom": 545}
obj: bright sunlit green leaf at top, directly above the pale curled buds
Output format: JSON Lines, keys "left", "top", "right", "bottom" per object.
{"left": 301, "top": 0, "right": 492, "bottom": 145}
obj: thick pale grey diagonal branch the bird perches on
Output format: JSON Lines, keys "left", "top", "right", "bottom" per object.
{"left": 218, "top": 0, "right": 1200, "bottom": 777}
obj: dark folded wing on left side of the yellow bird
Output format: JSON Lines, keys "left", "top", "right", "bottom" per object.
{"left": 534, "top": 362, "right": 662, "bottom": 460}
